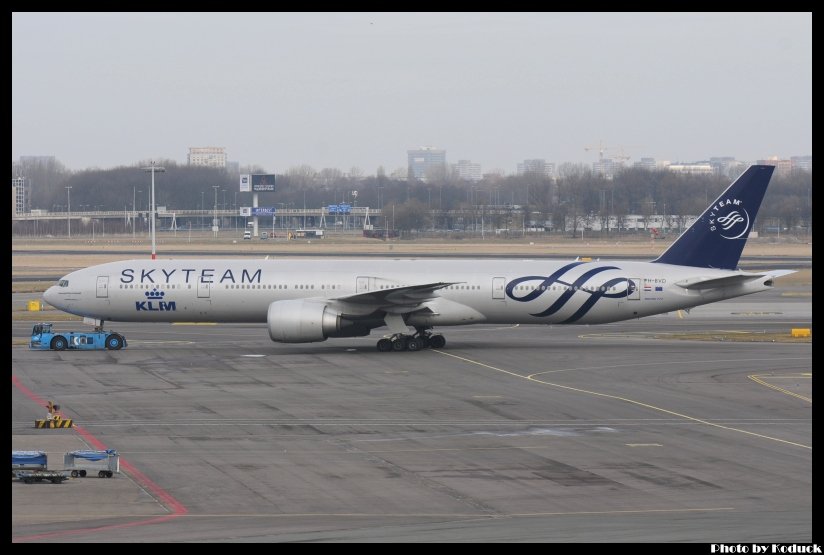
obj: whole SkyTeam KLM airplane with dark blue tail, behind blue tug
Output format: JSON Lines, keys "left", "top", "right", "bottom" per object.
{"left": 43, "top": 165, "right": 793, "bottom": 352}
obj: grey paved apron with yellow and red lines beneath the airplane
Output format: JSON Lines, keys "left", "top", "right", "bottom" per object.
{"left": 12, "top": 288, "right": 812, "bottom": 543}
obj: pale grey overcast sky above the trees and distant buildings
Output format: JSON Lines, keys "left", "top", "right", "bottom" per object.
{"left": 12, "top": 13, "right": 812, "bottom": 174}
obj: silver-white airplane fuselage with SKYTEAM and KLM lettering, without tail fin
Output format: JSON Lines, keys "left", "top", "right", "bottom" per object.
{"left": 44, "top": 258, "right": 771, "bottom": 326}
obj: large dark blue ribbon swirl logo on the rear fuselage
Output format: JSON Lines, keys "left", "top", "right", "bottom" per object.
{"left": 506, "top": 262, "right": 635, "bottom": 324}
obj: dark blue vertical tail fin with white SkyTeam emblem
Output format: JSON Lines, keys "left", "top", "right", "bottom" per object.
{"left": 653, "top": 166, "right": 775, "bottom": 270}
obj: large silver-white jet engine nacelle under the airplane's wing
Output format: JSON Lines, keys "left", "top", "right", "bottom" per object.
{"left": 266, "top": 299, "right": 370, "bottom": 343}
